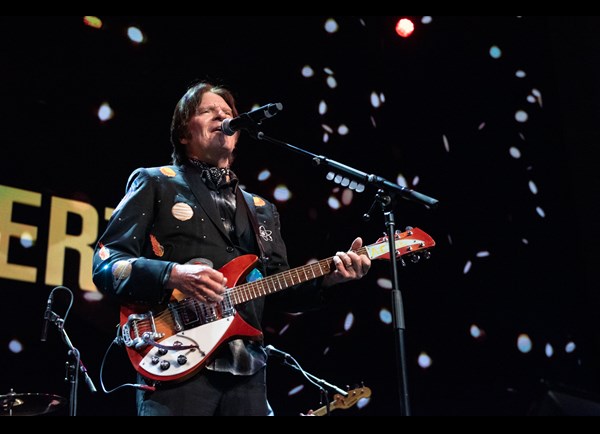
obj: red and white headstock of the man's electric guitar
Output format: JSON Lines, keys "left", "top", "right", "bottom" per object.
{"left": 366, "top": 228, "right": 435, "bottom": 262}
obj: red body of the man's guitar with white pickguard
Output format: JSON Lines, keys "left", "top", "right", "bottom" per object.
{"left": 120, "top": 255, "right": 262, "bottom": 381}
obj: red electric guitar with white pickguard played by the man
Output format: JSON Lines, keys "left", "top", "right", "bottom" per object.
{"left": 120, "top": 228, "right": 435, "bottom": 382}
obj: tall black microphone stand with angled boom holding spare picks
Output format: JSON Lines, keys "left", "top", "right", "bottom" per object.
{"left": 248, "top": 124, "right": 438, "bottom": 416}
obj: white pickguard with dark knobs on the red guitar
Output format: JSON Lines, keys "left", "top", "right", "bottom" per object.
{"left": 140, "top": 316, "right": 234, "bottom": 377}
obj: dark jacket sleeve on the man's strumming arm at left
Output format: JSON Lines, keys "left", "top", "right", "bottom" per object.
{"left": 93, "top": 169, "right": 175, "bottom": 305}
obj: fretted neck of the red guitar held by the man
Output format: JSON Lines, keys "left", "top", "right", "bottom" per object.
{"left": 229, "top": 247, "right": 368, "bottom": 305}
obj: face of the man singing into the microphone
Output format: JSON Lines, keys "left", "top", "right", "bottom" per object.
{"left": 181, "top": 92, "right": 238, "bottom": 167}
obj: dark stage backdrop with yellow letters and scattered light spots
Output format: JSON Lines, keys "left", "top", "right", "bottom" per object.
{"left": 0, "top": 16, "right": 600, "bottom": 417}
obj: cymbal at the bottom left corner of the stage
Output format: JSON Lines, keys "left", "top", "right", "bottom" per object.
{"left": 0, "top": 393, "right": 66, "bottom": 416}
